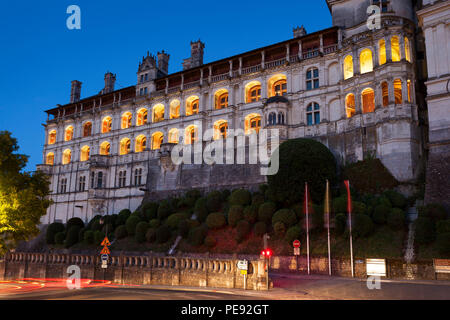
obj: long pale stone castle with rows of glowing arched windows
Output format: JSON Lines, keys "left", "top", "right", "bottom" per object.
{"left": 38, "top": 0, "right": 442, "bottom": 223}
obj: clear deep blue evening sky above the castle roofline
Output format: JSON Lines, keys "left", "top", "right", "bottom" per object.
{"left": 0, "top": 0, "right": 331, "bottom": 171}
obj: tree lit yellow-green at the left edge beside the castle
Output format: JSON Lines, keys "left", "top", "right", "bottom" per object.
{"left": 0, "top": 131, "right": 50, "bottom": 255}
